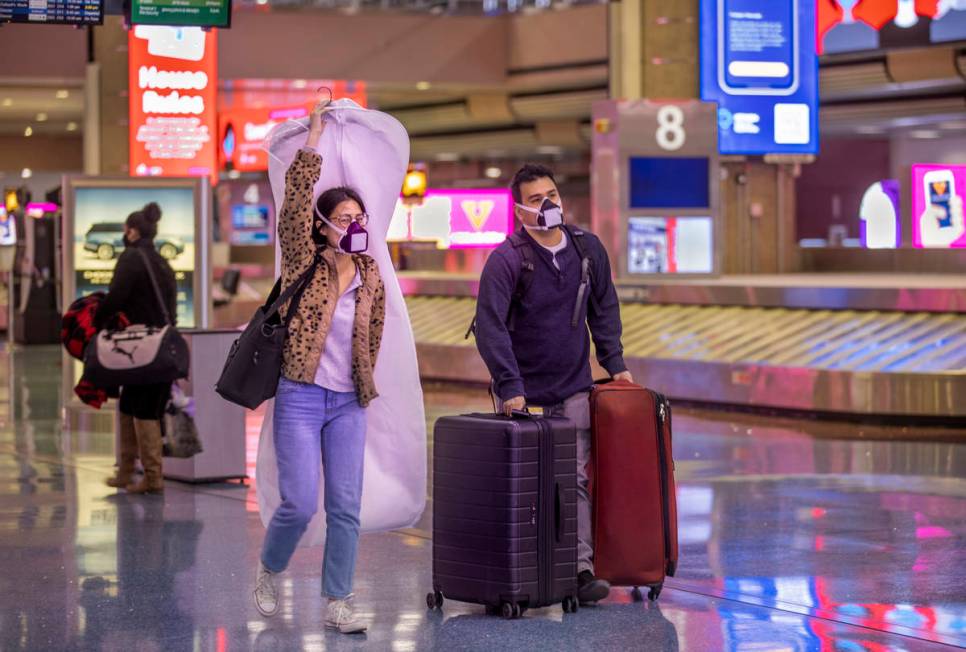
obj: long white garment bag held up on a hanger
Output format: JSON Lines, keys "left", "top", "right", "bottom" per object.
{"left": 256, "top": 99, "right": 426, "bottom": 546}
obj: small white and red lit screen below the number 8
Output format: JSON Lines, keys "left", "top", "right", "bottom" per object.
{"left": 627, "top": 217, "right": 714, "bottom": 274}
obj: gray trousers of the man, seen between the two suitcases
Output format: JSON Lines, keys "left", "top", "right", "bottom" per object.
{"left": 494, "top": 392, "right": 594, "bottom": 574}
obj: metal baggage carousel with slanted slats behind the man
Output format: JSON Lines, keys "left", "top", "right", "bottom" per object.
{"left": 400, "top": 273, "right": 966, "bottom": 423}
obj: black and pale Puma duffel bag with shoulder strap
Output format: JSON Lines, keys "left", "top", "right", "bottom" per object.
{"left": 84, "top": 249, "right": 191, "bottom": 387}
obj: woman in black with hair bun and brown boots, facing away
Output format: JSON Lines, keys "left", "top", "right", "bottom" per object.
{"left": 94, "top": 202, "right": 177, "bottom": 494}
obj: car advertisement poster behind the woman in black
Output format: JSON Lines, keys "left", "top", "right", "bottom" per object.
{"left": 73, "top": 186, "right": 196, "bottom": 328}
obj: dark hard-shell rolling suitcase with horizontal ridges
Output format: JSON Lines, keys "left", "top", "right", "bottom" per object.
{"left": 426, "top": 413, "right": 577, "bottom": 618}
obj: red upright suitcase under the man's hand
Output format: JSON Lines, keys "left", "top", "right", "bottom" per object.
{"left": 590, "top": 381, "right": 678, "bottom": 600}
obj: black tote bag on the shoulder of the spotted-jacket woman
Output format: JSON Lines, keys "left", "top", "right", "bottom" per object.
{"left": 215, "top": 255, "right": 322, "bottom": 410}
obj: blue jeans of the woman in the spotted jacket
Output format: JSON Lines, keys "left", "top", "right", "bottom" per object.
{"left": 262, "top": 378, "right": 366, "bottom": 599}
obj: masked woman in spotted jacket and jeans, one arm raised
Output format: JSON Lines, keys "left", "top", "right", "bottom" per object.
{"left": 255, "top": 105, "right": 385, "bottom": 634}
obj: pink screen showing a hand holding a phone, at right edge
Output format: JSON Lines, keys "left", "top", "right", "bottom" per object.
{"left": 912, "top": 163, "right": 966, "bottom": 249}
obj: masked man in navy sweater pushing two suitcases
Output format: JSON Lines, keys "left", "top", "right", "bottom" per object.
{"left": 476, "top": 164, "right": 633, "bottom": 604}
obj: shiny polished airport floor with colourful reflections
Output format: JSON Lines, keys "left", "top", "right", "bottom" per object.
{"left": 0, "top": 348, "right": 966, "bottom": 652}
